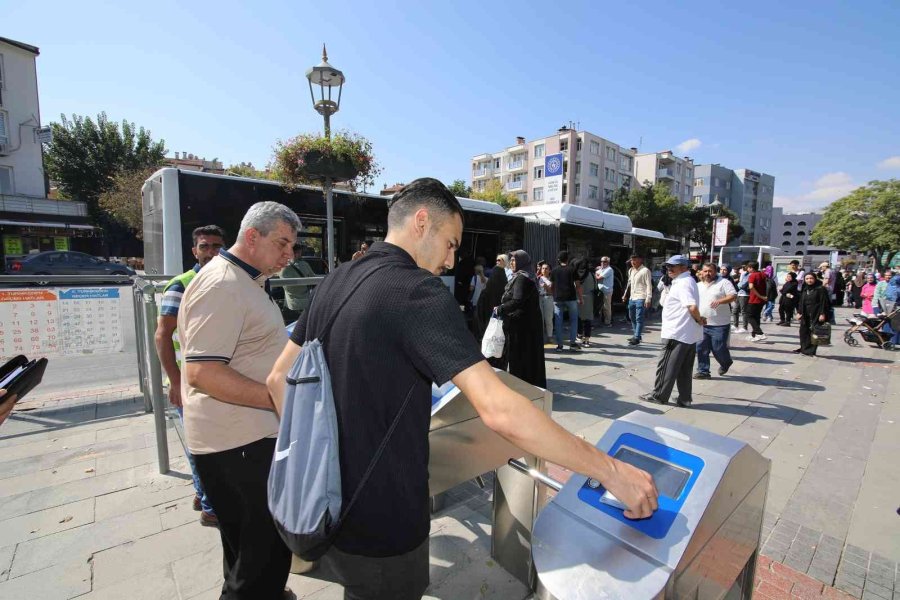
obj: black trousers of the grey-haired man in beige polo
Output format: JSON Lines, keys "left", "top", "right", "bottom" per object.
{"left": 194, "top": 438, "right": 291, "bottom": 600}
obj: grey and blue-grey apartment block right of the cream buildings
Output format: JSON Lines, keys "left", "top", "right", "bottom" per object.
{"left": 692, "top": 164, "right": 777, "bottom": 246}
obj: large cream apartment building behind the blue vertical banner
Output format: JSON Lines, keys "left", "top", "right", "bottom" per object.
{"left": 471, "top": 127, "right": 634, "bottom": 210}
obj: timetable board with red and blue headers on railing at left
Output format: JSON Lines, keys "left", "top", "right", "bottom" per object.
{"left": 0, "top": 287, "right": 124, "bottom": 360}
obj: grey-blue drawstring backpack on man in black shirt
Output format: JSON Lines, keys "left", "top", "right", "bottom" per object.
{"left": 268, "top": 265, "right": 412, "bottom": 561}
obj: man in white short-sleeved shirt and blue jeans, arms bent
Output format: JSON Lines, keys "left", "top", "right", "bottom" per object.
{"left": 694, "top": 263, "right": 737, "bottom": 379}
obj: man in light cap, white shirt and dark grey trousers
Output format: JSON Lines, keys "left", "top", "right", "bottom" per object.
{"left": 641, "top": 254, "right": 706, "bottom": 408}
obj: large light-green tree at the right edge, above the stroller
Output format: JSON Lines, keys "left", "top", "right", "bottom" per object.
{"left": 810, "top": 179, "right": 900, "bottom": 270}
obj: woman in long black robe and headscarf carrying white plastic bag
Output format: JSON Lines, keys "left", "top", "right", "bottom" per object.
{"left": 497, "top": 250, "right": 547, "bottom": 388}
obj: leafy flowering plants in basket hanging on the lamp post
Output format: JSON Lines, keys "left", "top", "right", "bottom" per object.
{"left": 273, "top": 131, "right": 381, "bottom": 190}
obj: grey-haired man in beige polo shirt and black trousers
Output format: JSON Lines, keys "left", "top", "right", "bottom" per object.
{"left": 178, "top": 202, "right": 300, "bottom": 600}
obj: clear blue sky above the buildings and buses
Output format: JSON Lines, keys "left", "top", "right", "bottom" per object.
{"left": 0, "top": 0, "right": 900, "bottom": 210}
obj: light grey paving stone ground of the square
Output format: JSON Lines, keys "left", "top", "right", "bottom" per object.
{"left": 0, "top": 309, "right": 900, "bottom": 600}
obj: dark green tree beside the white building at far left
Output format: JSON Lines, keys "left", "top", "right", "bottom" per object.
{"left": 44, "top": 113, "right": 166, "bottom": 226}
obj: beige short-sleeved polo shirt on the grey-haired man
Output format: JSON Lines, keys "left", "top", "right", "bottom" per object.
{"left": 178, "top": 250, "right": 288, "bottom": 454}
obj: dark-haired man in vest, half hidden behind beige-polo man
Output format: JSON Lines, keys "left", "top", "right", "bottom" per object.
{"left": 155, "top": 225, "right": 225, "bottom": 527}
